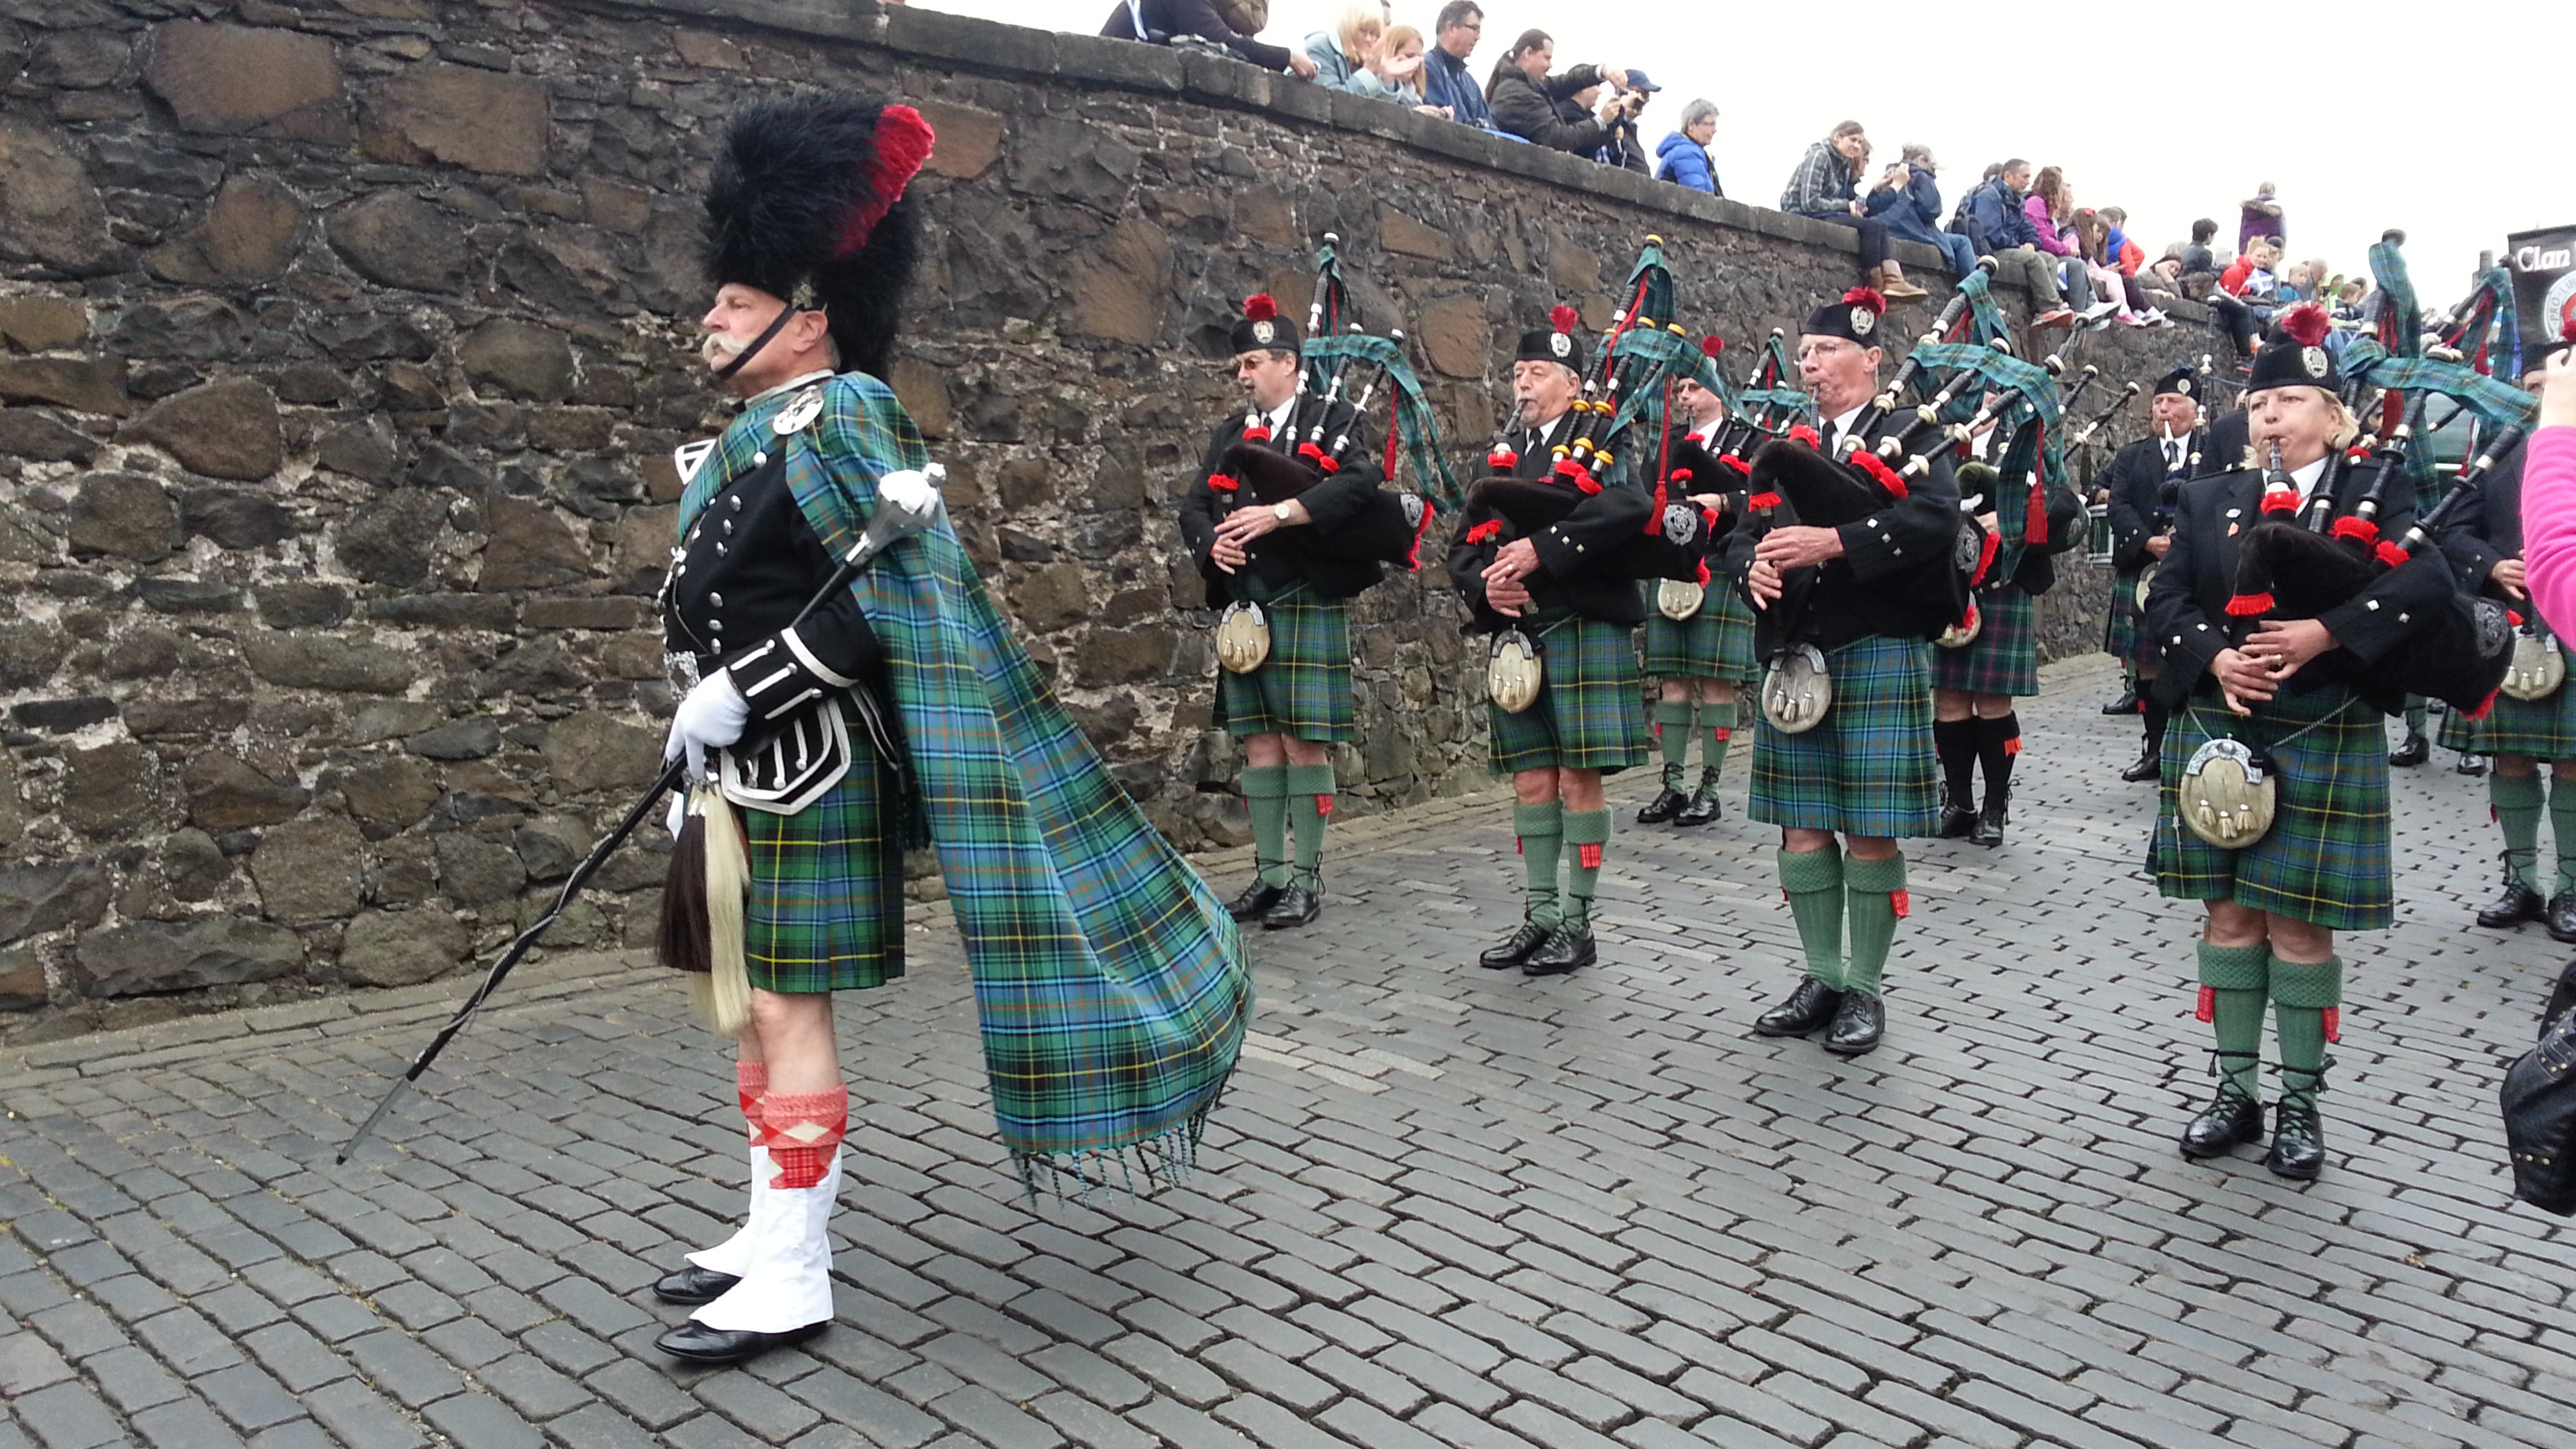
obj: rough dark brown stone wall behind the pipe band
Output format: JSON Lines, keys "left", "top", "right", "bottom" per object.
{"left": 0, "top": 0, "right": 2211, "bottom": 1034}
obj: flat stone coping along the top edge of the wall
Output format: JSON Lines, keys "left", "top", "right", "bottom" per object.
{"left": 572, "top": 0, "right": 2211, "bottom": 322}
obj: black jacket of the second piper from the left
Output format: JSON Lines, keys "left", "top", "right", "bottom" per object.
{"left": 1447, "top": 413, "right": 1653, "bottom": 635}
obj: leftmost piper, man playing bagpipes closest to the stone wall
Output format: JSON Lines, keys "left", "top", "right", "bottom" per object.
{"left": 1180, "top": 265, "right": 1430, "bottom": 930}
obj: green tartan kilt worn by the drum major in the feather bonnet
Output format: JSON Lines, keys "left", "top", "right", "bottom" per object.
{"left": 734, "top": 701, "right": 904, "bottom": 993}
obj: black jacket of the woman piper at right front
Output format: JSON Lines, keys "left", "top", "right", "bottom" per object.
{"left": 2146, "top": 464, "right": 2452, "bottom": 712}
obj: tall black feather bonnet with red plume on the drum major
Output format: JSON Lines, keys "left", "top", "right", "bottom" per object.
{"left": 706, "top": 95, "right": 933, "bottom": 376}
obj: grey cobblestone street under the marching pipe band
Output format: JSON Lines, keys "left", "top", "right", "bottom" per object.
{"left": 0, "top": 660, "right": 2576, "bottom": 1449}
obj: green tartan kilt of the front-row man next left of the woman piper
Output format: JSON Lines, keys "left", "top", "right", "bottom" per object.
{"left": 1749, "top": 635, "right": 1940, "bottom": 835}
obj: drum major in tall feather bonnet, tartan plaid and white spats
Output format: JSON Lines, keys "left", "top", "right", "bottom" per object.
{"left": 644, "top": 95, "right": 1252, "bottom": 1364}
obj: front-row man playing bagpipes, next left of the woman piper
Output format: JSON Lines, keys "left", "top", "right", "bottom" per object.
{"left": 1726, "top": 289, "right": 1975, "bottom": 1054}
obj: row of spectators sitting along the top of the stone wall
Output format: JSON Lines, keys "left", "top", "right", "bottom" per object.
{"left": 1100, "top": 0, "right": 2370, "bottom": 356}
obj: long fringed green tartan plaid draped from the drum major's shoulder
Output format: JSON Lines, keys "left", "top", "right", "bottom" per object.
{"left": 680, "top": 374, "right": 1252, "bottom": 1191}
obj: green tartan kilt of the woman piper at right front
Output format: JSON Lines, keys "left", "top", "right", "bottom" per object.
{"left": 2146, "top": 686, "right": 2396, "bottom": 930}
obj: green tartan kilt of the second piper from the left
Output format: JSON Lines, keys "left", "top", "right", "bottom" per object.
{"left": 1468, "top": 614, "right": 1651, "bottom": 776}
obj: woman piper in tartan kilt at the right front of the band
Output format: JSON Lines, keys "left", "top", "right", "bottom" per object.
{"left": 2146, "top": 304, "right": 2504, "bottom": 1178}
